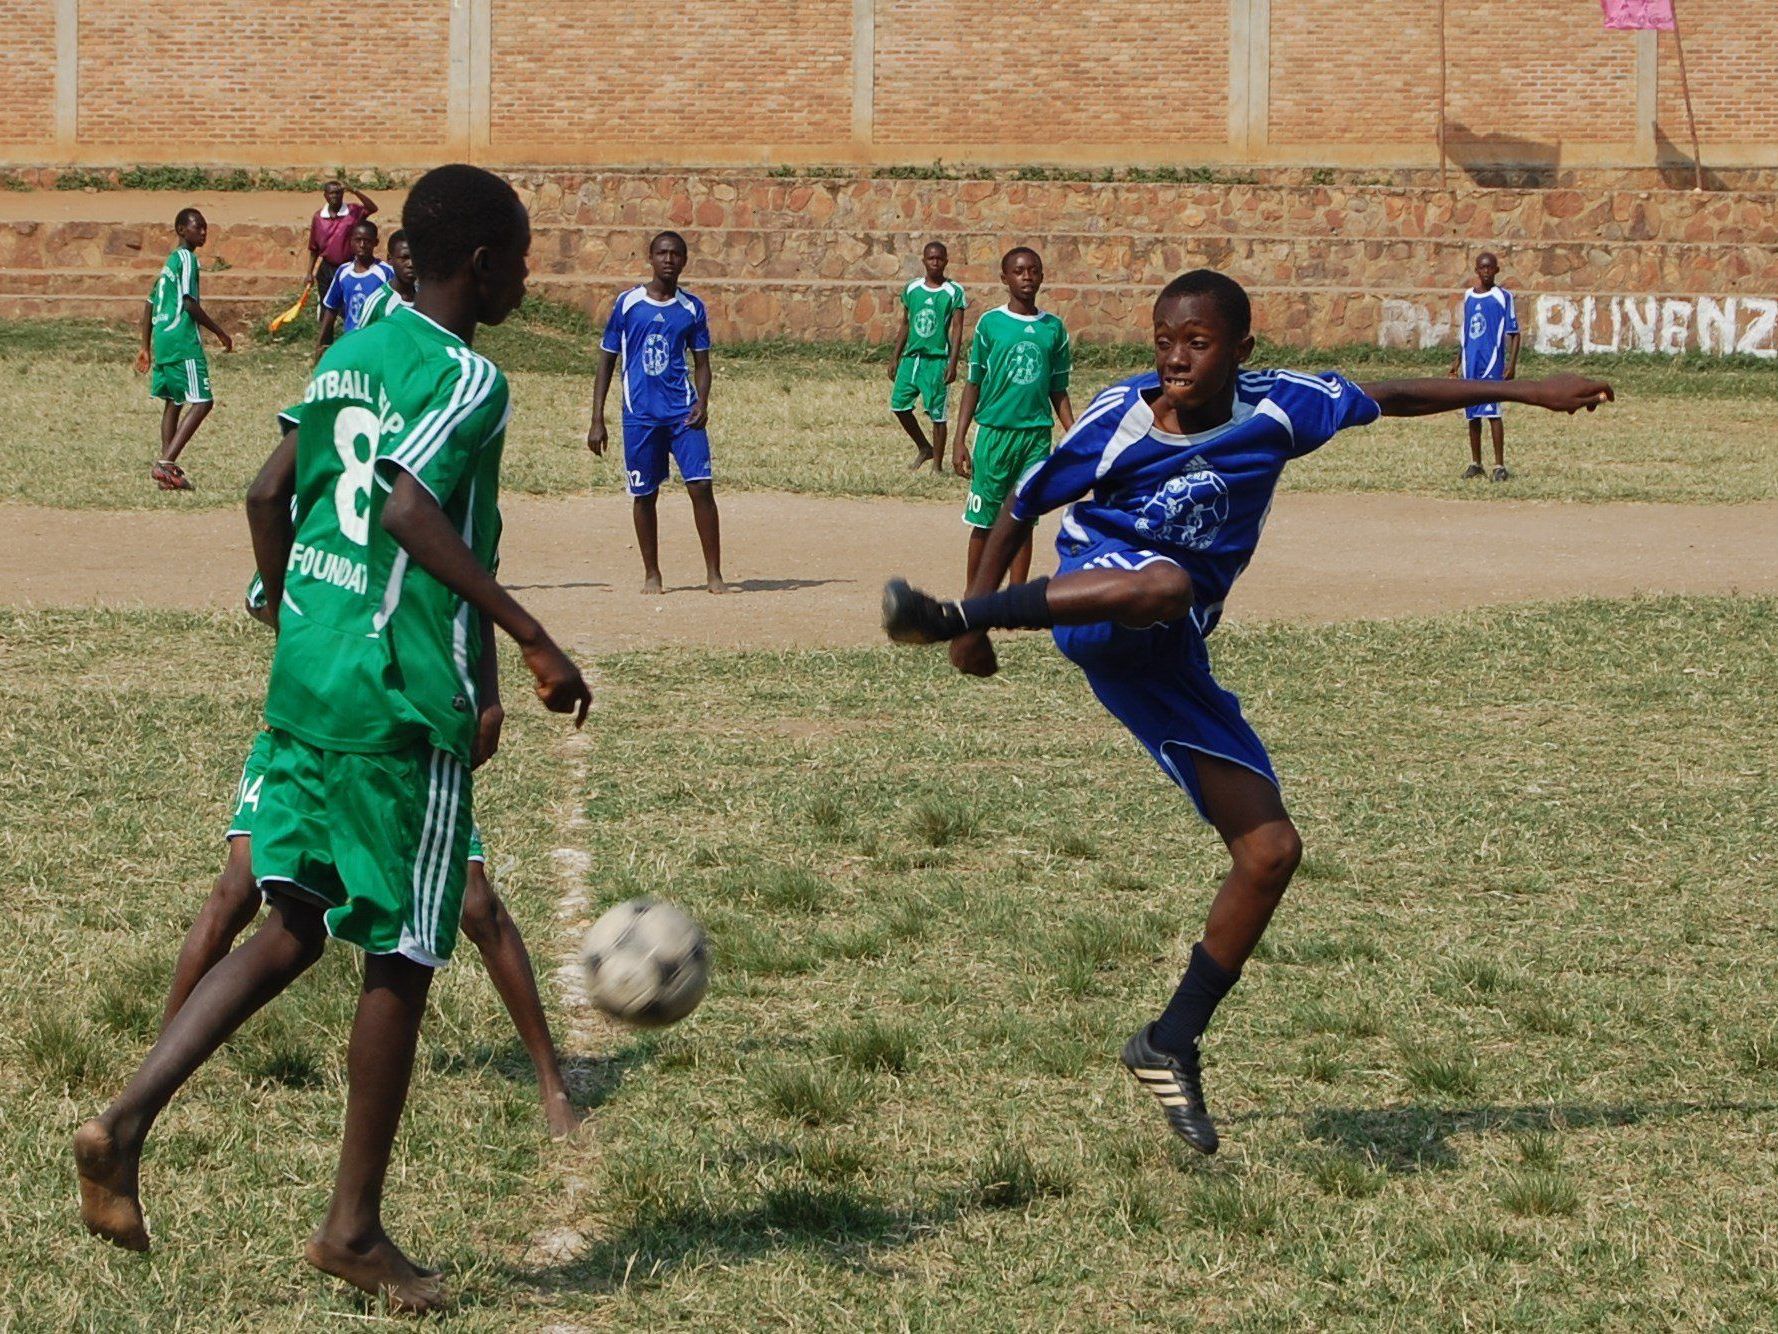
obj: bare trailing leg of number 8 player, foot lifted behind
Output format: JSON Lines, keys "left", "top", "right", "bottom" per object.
{"left": 75, "top": 896, "right": 327, "bottom": 1250}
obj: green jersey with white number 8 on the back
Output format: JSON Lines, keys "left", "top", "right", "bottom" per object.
{"left": 265, "top": 306, "right": 510, "bottom": 761}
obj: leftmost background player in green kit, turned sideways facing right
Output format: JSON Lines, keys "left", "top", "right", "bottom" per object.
{"left": 135, "top": 208, "right": 235, "bottom": 491}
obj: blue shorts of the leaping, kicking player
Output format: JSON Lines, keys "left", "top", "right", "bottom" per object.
{"left": 1051, "top": 548, "right": 1278, "bottom": 820}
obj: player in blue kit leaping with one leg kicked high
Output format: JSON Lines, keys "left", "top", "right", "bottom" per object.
{"left": 884, "top": 269, "right": 1611, "bottom": 1153}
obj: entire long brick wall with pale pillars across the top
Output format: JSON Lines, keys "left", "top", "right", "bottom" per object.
{"left": 10, "top": 0, "right": 1778, "bottom": 171}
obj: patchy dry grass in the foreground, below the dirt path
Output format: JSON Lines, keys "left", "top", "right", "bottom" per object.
{"left": 0, "top": 599, "right": 1778, "bottom": 1330}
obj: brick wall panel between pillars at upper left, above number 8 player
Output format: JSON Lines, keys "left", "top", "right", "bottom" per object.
{"left": 75, "top": 0, "right": 450, "bottom": 150}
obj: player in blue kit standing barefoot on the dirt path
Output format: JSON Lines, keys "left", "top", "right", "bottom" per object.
{"left": 587, "top": 231, "right": 729, "bottom": 592}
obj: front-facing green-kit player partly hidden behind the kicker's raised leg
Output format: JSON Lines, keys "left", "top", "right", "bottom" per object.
{"left": 955, "top": 245, "right": 1074, "bottom": 583}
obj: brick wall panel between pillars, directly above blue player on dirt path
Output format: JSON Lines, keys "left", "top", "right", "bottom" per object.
{"left": 491, "top": 0, "right": 852, "bottom": 152}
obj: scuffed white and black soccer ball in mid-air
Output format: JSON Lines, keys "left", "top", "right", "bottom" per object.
{"left": 580, "top": 898, "right": 709, "bottom": 1028}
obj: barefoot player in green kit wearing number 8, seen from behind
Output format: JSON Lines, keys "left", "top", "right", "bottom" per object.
{"left": 75, "top": 165, "right": 590, "bottom": 1313}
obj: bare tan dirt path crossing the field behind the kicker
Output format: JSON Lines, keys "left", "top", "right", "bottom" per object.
{"left": 0, "top": 493, "right": 1778, "bottom": 651}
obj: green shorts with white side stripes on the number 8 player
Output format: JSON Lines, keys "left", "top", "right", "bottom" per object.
{"left": 252, "top": 731, "right": 473, "bottom": 968}
